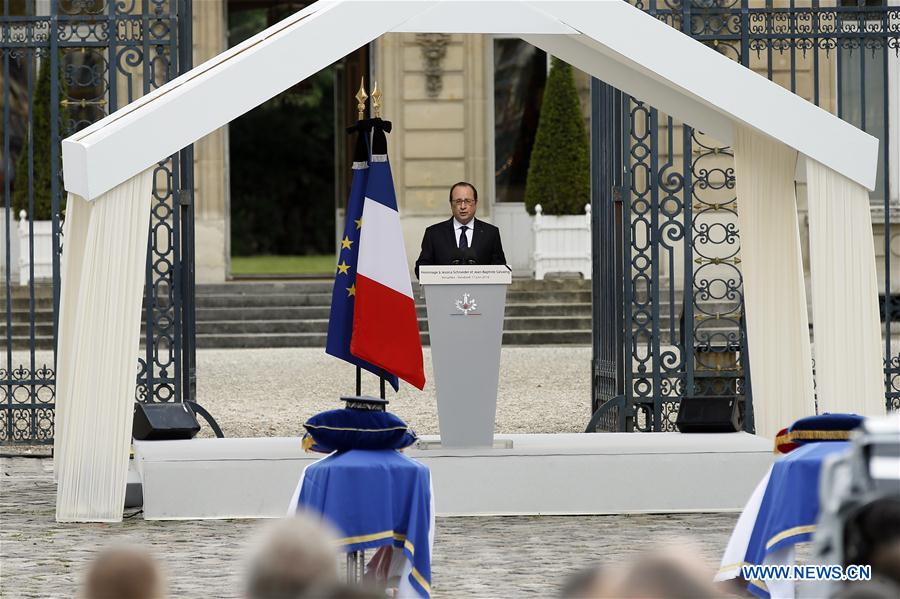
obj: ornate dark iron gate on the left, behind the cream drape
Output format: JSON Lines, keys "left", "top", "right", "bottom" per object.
{"left": 0, "top": 0, "right": 194, "bottom": 444}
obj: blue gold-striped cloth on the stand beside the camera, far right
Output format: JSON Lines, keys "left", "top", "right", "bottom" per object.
{"left": 744, "top": 441, "right": 850, "bottom": 599}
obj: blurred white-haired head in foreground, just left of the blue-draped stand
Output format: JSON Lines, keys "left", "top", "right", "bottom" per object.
{"left": 247, "top": 514, "right": 338, "bottom": 599}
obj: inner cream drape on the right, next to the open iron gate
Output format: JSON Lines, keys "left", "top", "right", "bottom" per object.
{"left": 734, "top": 127, "right": 815, "bottom": 438}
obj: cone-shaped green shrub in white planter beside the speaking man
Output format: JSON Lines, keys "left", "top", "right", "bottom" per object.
{"left": 525, "top": 58, "right": 591, "bottom": 279}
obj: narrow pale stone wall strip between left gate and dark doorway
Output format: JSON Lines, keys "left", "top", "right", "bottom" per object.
{"left": 193, "top": 0, "right": 231, "bottom": 283}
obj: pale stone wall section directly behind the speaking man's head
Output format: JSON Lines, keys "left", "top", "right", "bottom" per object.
{"left": 372, "top": 34, "right": 492, "bottom": 268}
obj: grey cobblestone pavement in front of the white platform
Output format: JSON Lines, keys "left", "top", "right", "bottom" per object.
{"left": 0, "top": 458, "right": 737, "bottom": 599}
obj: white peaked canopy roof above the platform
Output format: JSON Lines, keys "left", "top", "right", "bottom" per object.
{"left": 63, "top": 0, "right": 878, "bottom": 199}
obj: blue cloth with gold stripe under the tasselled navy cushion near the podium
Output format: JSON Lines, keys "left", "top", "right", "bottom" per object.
{"left": 297, "top": 449, "right": 433, "bottom": 597}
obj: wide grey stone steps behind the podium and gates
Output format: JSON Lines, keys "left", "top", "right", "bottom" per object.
{"left": 0, "top": 279, "right": 900, "bottom": 351}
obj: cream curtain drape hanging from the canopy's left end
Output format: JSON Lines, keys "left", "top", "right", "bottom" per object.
{"left": 54, "top": 169, "right": 153, "bottom": 522}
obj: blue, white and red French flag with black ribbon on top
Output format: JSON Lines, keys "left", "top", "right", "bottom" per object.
{"left": 350, "top": 124, "right": 425, "bottom": 389}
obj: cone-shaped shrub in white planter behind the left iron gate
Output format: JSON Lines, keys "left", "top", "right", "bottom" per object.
{"left": 12, "top": 56, "right": 68, "bottom": 285}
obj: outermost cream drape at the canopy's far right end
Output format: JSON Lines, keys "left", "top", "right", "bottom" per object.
{"left": 806, "top": 158, "right": 885, "bottom": 416}
